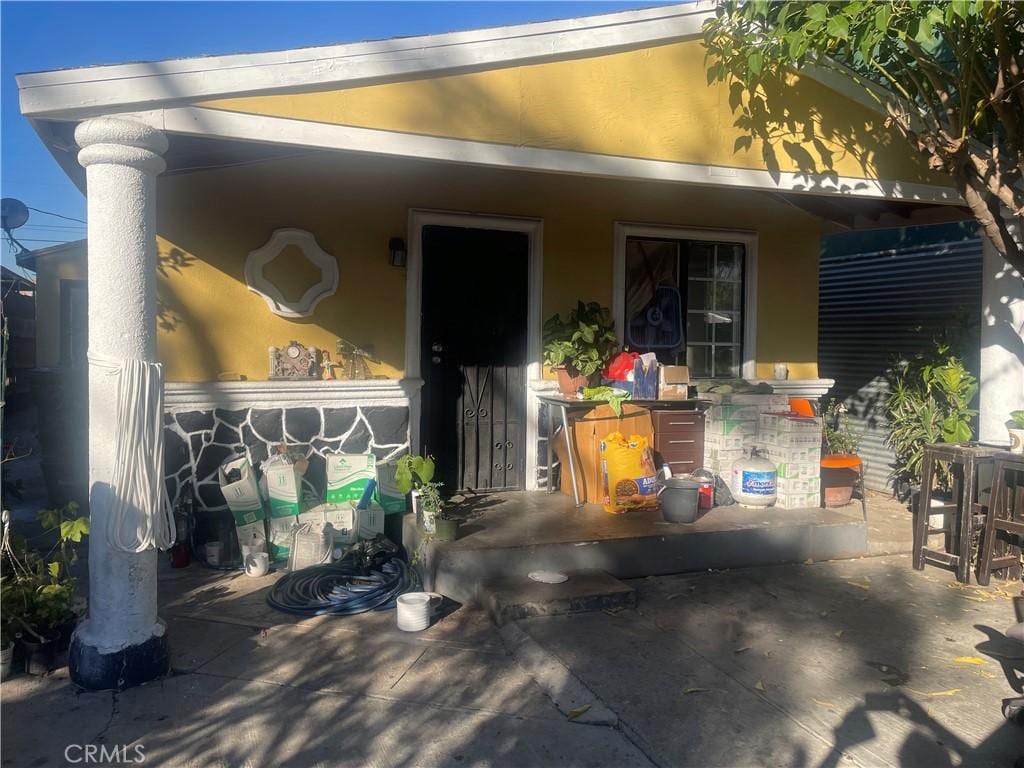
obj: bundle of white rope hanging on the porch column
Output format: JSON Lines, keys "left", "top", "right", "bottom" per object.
{"left": 89, "top": 352, "right": 175, "bottom": 552}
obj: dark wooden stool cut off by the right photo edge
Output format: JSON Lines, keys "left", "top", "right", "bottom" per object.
{"left": 978, "top": 453, "right": 1024, "bottom": 585}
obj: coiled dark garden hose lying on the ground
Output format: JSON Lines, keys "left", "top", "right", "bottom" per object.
{"left": 266, "top": 557, "right": 420, "bottom": 616}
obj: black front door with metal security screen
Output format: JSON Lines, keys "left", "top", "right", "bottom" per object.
{"left": 420, "top": 225, "right": 529, "bottom": 493}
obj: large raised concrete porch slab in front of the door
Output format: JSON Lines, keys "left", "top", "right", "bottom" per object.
{"left": 403, "top": 492, "right": 867, "bottom": 603}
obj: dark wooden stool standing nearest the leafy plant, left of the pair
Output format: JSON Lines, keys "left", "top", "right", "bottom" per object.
{"left": 913, "top": 442, "right": 997, "bottom": 584}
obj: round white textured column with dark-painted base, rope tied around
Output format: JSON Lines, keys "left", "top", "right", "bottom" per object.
{"left": 70, "top": 118, "right": 168, "bottom": 689}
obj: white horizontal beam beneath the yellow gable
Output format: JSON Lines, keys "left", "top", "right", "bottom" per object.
{"left": 155, "top": 106, "right": 963, "bottom": 205}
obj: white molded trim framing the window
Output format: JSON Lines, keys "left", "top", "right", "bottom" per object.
{"left": 611, "top": 221, "right": 758, "bottom": 379}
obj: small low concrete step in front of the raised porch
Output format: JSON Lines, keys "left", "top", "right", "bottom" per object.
{"left": 480, "top": 570, "right": 637, "bottom": 627}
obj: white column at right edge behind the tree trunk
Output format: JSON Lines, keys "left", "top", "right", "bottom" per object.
{"left": 978, "top": 222, "right": 1024, "bottom": 445}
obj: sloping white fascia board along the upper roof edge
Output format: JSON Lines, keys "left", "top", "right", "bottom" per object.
{"left": 16, "top": 0, "right": 715, "bottom": 120}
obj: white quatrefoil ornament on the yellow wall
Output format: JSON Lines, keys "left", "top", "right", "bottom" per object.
{"left": 246, "top": 228, "right": 338, "bottom": 317}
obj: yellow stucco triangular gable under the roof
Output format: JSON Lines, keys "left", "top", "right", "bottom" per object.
{"left": 202, "top": 40, "right": 948, "bottom": 186}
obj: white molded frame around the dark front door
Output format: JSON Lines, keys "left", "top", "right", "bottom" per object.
{"left": 406, "top": 208, "right": 544, "bottom": 490}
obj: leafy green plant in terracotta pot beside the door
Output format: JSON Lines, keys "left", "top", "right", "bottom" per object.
{"left": 544, "top": 301, "right": 618, "bottom": 397}
